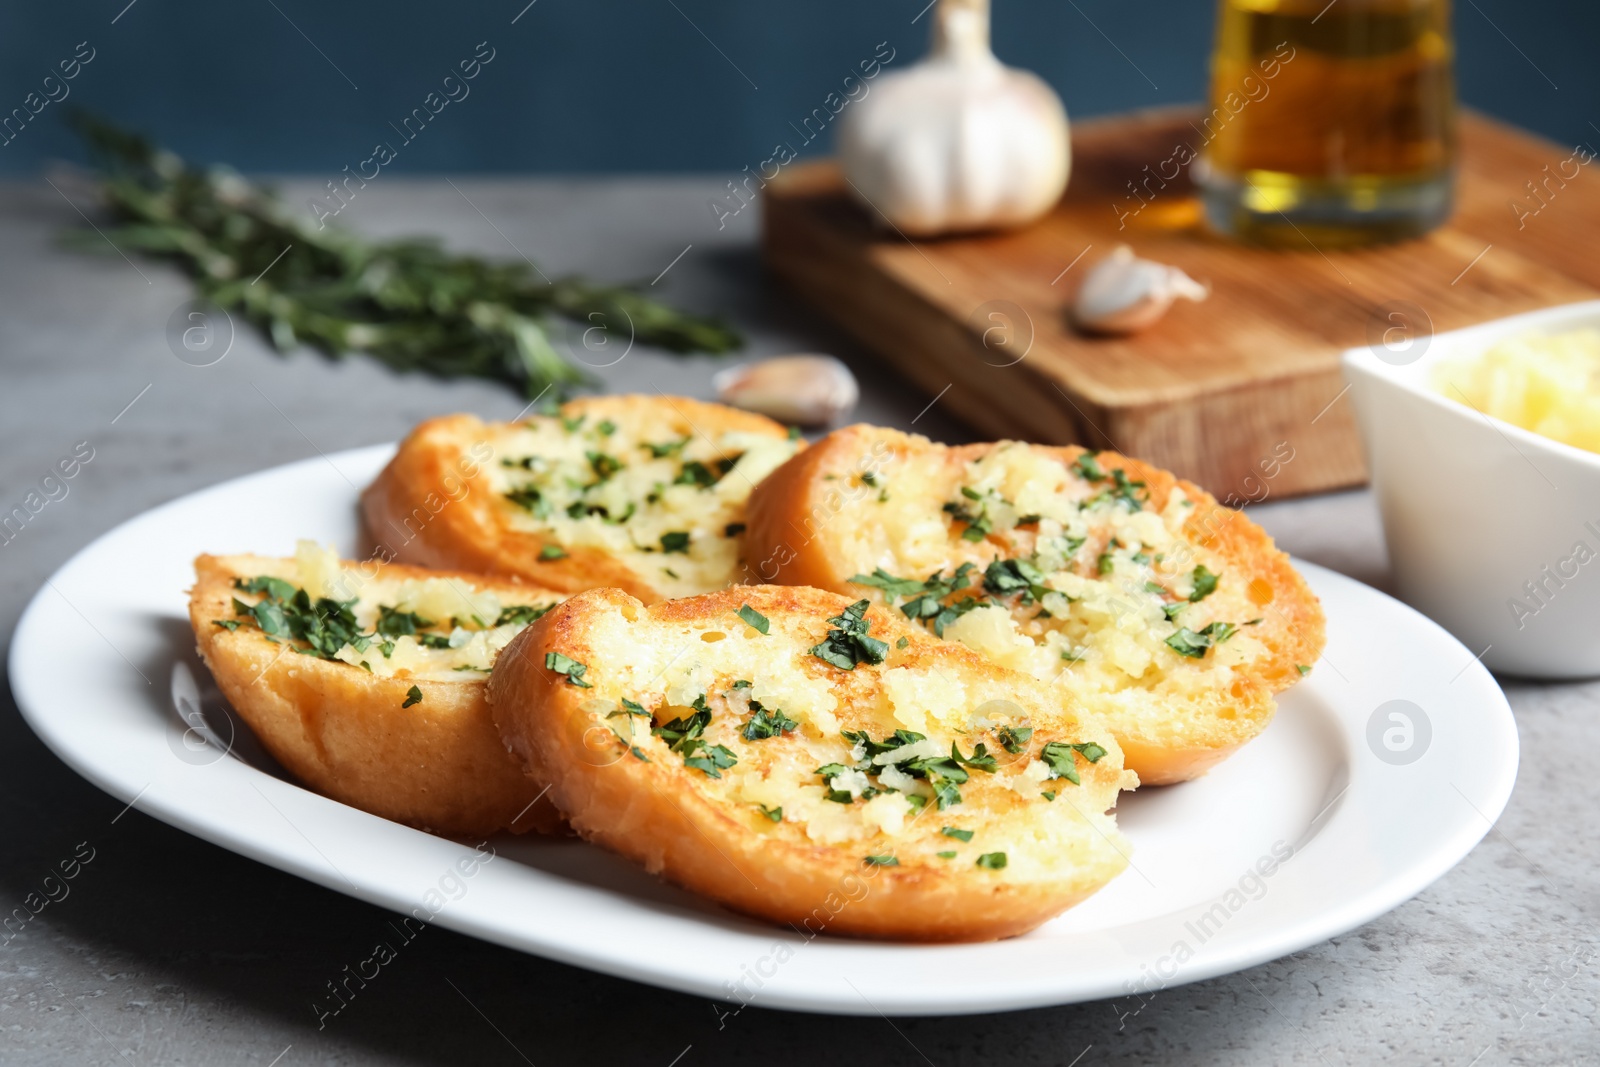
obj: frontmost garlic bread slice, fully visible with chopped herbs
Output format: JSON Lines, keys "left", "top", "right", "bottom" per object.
{"left": 490, "top": 585, "right": 1136, "bottom": 941}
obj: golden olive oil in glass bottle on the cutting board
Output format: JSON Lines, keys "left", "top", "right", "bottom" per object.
{"left": 1195, "top": 0, "right": 1456, "bottom": 248}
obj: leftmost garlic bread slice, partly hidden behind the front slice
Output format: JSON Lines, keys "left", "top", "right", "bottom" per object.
{"left": 189, "top": 541, "right": 562, "bottom": 837}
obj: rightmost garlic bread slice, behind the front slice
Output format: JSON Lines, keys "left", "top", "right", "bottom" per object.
{"left": 746, "top": 426, "right": 1323, "bottom": 785}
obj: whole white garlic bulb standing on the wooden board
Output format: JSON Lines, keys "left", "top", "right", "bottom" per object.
{"left": 838, "top": 0, "right": 1072, "bottom": 237}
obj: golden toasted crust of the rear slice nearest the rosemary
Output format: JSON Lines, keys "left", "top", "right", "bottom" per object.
{"left": 362, "top": 395, "right": 787, "bottom": 603}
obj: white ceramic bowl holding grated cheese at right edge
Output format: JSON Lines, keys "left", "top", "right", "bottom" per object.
{"left": 1344, "top": 301, "right": 1600, "bottom": 678}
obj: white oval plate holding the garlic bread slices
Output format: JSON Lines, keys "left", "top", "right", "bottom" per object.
{"left": 10, "top": 446, "right": 1517, "bottom": 1014}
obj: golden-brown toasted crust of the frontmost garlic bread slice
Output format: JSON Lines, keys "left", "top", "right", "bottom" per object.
{"left": 490, "top": 585, "right": 1134, "bottom": 941}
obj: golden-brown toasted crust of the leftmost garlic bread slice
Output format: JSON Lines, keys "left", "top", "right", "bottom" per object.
{"left": 189, "top": 555, "right": 565, "bottom": 837}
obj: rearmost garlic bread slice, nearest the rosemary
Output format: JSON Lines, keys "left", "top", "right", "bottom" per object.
{"left": 362, "top": 397, "right": 803, "bottom": 601}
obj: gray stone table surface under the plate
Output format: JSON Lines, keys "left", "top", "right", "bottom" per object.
{"left": 0, "top": 178, "right": 1600, "bottom": 1067}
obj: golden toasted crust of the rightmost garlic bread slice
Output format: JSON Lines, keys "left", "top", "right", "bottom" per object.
{"left": 744, "top": 426, "right": 1325, "bottom": 785}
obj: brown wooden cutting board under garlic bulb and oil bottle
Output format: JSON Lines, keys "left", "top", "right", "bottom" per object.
{"left": 763, "top": 109, "right": 1600, "bottom": 501}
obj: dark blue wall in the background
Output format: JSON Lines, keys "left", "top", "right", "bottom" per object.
{"left": 0, "top": 0, "right": 1600, "bottom": 176}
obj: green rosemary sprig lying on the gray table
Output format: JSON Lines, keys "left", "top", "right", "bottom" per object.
{"left": 60, "top": 112, "right": 742, "bottom": 397}
